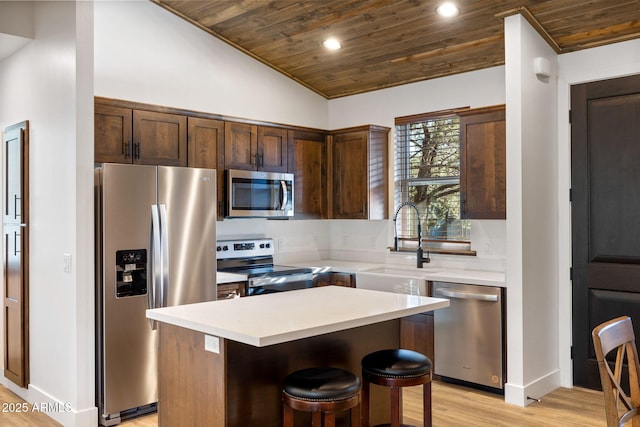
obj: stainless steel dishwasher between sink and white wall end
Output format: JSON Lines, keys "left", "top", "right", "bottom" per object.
{"left": 433, "top": 282, "right": 506, "bottom": 391}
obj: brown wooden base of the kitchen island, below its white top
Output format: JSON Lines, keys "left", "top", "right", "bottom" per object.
{"left": 158, "top": 320, "right": 400, "bottom": 427}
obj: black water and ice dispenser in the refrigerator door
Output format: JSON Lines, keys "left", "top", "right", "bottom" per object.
{"left": 116, "top": 249, "right": 147, "bottom": 298}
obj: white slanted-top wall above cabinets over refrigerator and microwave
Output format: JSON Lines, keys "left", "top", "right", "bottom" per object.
{"left": 95, "top": 1, "right": 327, "bottom": 129}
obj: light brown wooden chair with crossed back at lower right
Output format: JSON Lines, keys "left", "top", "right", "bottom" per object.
{"left": 592, "top": 316, "right": 640, "bottom": 427}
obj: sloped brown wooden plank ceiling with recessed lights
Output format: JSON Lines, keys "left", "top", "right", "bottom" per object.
{"left": 152, "top": 0, "right": 640, "bottom": 99}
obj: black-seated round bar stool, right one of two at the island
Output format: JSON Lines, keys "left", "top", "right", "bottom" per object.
{"left": 362, "top": 349, "right": 432, "bottom": 427}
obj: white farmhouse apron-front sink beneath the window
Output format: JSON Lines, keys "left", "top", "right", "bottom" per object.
{"left": 356, "top": 267, "right": 435, "bottom": 296}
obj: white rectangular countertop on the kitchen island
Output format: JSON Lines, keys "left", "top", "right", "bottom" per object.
{"left": 147, "top": 286, "right": 449, "bottom": 347}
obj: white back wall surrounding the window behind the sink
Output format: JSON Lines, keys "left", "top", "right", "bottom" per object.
{"left": 329, "top": 67, "right": 506, "bottom": 271}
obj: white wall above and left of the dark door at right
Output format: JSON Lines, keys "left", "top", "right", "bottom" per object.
{"left": 557, "top": 40, "right": 640, "bottom": 387}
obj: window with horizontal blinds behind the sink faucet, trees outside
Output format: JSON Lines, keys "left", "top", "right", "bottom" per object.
{"left": 394, "top": 111, "right": 471, "bottom": 246}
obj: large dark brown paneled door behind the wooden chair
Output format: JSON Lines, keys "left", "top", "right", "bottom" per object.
{"left": 571, "top": 75, "right": 640, "bottom": 389}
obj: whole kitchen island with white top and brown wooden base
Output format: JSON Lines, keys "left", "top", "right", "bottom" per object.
{"left": 147, "top": 286, "right": 449, "bottom": 427}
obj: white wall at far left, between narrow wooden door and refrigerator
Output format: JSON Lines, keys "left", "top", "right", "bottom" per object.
{"left": 0, "top": 2, "right": 97, "bottom": 426}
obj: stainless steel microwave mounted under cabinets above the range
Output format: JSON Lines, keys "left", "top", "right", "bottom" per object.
{"left": 225, "top": 169, "right": 293, "bottom": 218}
